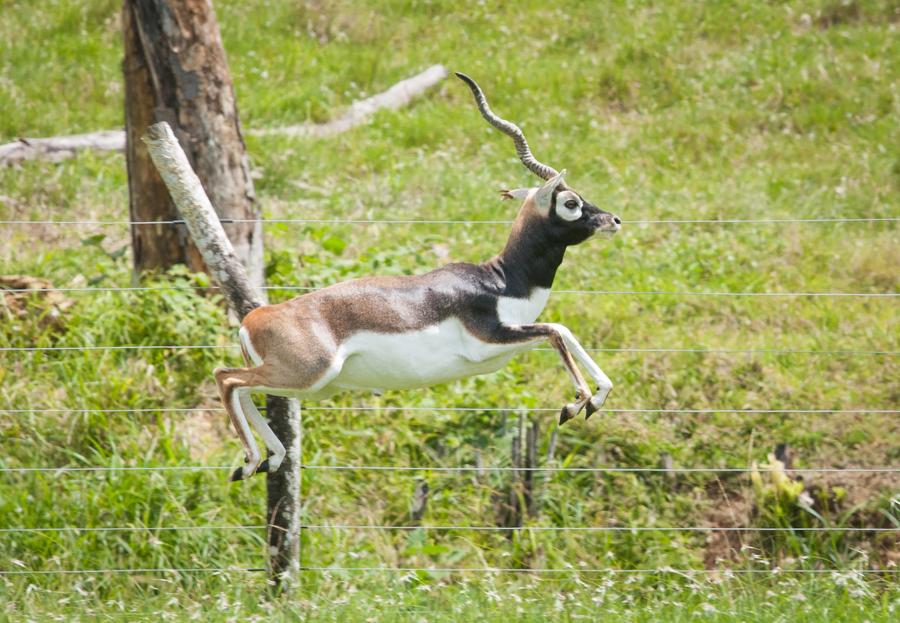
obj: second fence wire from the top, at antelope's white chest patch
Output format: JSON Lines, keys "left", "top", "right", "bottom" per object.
{"left": 0, "top": 285, "right": 900, "bottom": 298}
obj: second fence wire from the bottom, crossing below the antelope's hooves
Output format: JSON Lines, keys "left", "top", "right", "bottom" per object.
{"left": 0, "top": 524, "right": 900, "bottom": 534}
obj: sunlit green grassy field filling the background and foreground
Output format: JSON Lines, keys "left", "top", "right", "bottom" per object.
{"left": 0, "top": 0, "right": 900, "bottom": 621}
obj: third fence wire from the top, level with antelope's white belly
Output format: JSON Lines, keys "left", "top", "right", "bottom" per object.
{"left": 0, "top": 344, "right": 900, "bottom": 357}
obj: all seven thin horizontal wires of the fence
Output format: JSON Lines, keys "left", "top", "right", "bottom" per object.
{"left": 0, "top": 140, "right": 900, "bottom": 576}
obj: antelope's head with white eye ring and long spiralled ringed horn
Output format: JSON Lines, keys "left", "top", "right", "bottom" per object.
{"left": 456, "top": 72, "right": 622, "bottom": 246}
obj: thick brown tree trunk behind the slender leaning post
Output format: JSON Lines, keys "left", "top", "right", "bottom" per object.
{"left": 122, "top": 0, "right": 263, "bottom": 286}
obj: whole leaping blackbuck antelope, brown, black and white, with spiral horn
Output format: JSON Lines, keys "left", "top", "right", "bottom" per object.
{"left": 215, "top": 73, "right": 620, "bottom": 480}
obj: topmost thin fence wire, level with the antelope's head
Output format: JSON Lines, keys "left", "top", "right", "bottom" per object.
{"left": 0, "top": 216, "right": 900, "bottom": 226}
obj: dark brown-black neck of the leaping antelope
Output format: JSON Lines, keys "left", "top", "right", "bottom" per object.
{"left": 488, "top": 221, "right": 566, "bottom": 298}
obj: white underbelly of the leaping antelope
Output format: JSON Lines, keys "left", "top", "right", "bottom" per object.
{"left": 328, "top": 318, "right": 532, "bottom": 389}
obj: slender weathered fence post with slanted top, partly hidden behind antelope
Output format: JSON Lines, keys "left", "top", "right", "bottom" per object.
{"left": 142, "top": 122, "right": 301, "bottom": 588}
